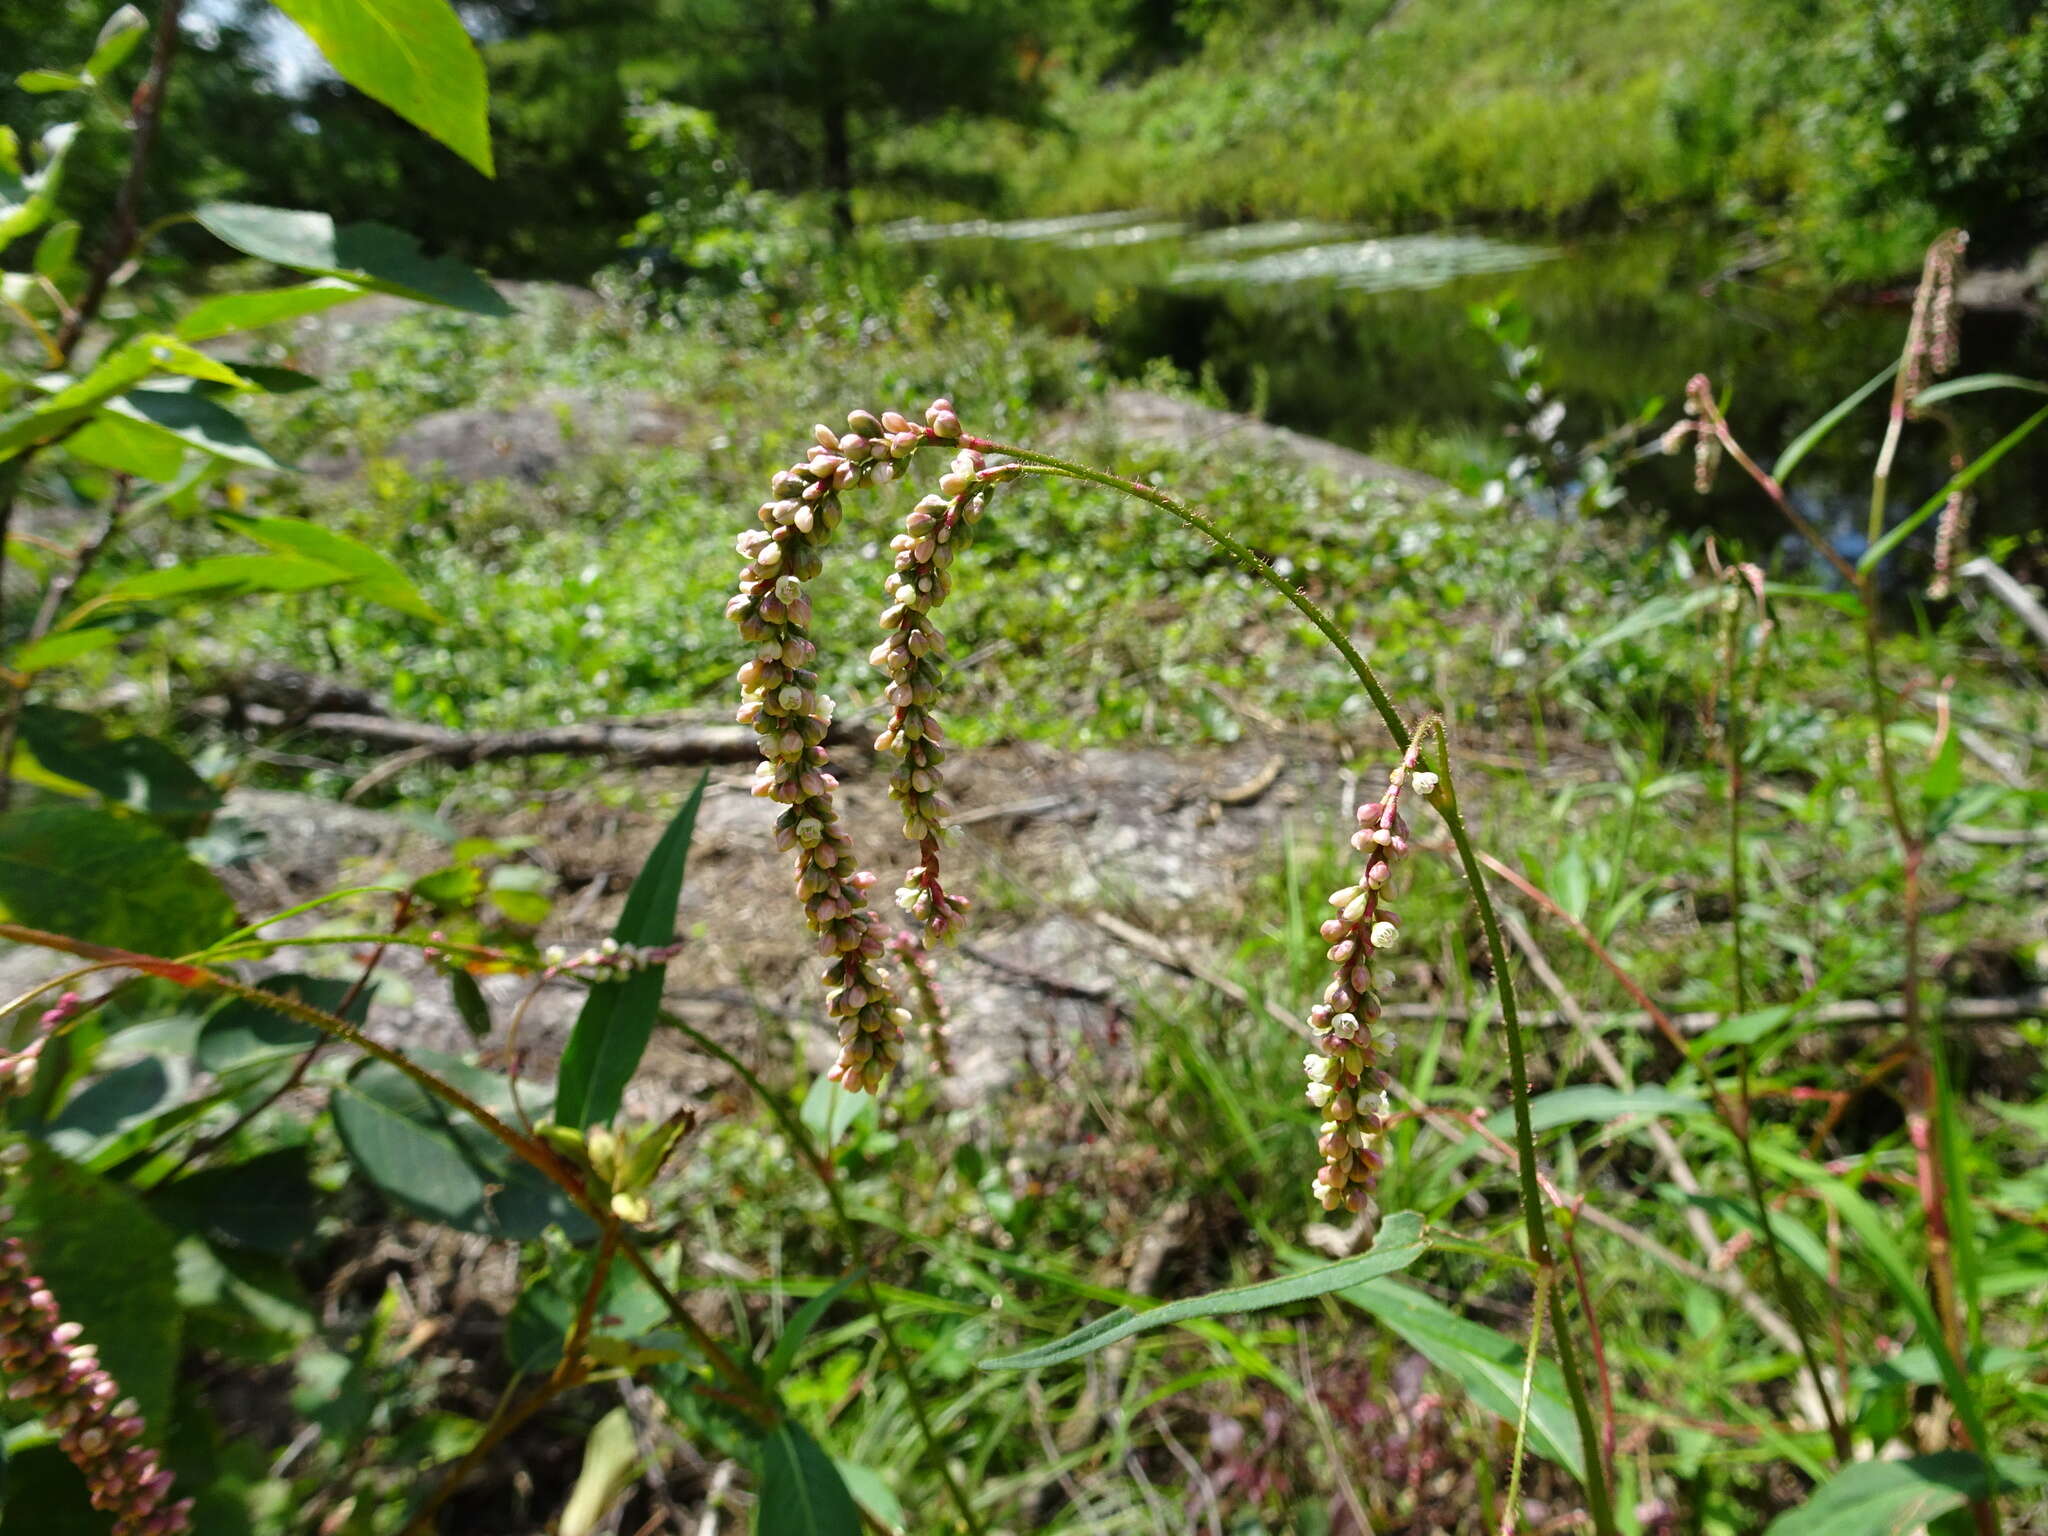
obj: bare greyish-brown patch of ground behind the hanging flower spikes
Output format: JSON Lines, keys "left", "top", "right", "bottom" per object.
{"left": 180, "top": 739, "right": 1352, "bottom": 1116}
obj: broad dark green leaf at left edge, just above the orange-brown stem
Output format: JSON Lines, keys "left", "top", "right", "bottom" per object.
{"left": 0, "top": 805, "right": 236, "bottom": 954}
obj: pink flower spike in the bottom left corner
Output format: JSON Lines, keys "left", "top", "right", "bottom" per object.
{"left": 0, "top": 1210, "right": 193, "bottom": 1536}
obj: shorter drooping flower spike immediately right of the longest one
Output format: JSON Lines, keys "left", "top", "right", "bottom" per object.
{"left": 868, "top": 423, "right": 989, "bottom": 940}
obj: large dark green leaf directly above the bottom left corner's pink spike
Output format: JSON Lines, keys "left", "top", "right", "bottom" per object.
{"left": 8, "top": 1147, "right": 178, "bottom": 1438}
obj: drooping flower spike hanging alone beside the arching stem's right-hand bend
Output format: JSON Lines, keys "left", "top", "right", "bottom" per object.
{"left": 1303, "top": 753, "right": 1438, "bottom": 1210}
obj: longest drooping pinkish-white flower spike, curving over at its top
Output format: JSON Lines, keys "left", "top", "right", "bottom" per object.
{"left": 725, "top": 401, "right": 961, "bottom": 1092}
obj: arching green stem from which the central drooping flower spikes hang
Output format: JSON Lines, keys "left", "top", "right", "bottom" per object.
{"left": 961, "top": 436, "right": 1616, "bottom": 1536}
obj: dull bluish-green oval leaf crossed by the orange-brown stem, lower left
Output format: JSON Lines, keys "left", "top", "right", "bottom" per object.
{"left": 330, "top": 1051, "right": 592, "bottom": 1241}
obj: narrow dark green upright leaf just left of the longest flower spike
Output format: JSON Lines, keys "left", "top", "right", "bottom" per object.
{"left": 555, "top": 772, "right": 711, "bottom": 1130}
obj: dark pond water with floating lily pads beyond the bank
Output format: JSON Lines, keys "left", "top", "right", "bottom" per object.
{"left": 883, "top": 211, "right": 2048, "bottom": 573}
